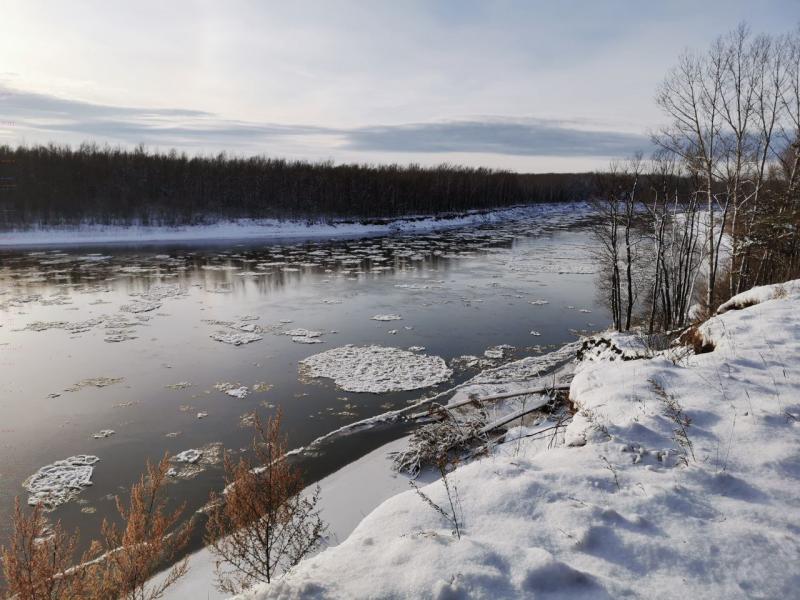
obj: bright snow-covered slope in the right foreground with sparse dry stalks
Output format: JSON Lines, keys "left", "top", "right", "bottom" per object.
{"left": 239, "top": 283, "right": 800, "bottom": 600}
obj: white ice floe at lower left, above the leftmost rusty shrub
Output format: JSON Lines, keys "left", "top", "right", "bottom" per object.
{"left": 22, "top": 454, "right": 100, "bottom": 510}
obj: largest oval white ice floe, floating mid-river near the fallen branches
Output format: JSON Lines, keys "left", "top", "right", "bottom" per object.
{"left": 300, "top": 345, "right": 453, "bottom": 393}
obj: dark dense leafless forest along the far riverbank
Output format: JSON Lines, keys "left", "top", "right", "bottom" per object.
{"left": 0, "top": 144, "right": 592, "bottom": 228}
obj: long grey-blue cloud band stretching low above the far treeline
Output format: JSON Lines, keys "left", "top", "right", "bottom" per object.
{"left": 0, "top": 85, "right": 649, "bottom": 157}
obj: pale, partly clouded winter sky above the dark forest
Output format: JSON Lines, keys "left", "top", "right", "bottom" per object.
{"left": 0, "top": 0, "right": 800, "bottom": 172}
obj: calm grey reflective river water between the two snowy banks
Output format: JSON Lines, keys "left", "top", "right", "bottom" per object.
{"left": 0, "top": 207, "right": 608, "bottom": 552}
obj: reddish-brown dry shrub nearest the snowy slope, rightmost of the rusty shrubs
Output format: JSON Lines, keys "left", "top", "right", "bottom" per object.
{"left": 206, "top": 412, "right": 325, "bottom": 593}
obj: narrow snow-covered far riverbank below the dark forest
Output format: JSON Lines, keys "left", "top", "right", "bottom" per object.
{"left": 0, "top": 203, "right": 586, "bottom": 247}
